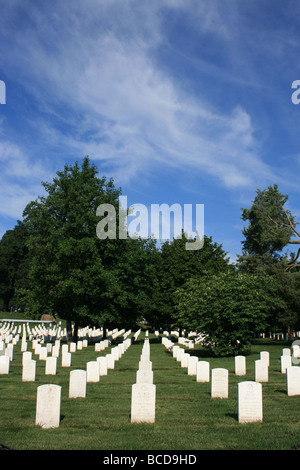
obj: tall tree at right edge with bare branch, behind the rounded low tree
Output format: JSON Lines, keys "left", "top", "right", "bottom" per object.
{"left": 237, "top": 184, "right": 300, "bottom": 332}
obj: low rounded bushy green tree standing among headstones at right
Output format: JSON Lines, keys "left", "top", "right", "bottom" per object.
{"left": 176, "top": 270, "right": 283, "bottom": 356}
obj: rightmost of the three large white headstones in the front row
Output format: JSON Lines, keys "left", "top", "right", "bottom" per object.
{"left": 238, "top": 381, "right": 263, "bottom": 423}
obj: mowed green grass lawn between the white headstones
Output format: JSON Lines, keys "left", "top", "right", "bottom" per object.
{"left": 0, "top": 333, "right": 300, "bottom": 451}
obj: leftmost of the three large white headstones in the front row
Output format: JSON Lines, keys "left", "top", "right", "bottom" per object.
{"left": 35, "top": 384, "right": 61, "bottom": 429}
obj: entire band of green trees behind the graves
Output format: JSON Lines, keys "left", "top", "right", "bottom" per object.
{"left": 0, "top": 157, "right": 300, "bottom": 355}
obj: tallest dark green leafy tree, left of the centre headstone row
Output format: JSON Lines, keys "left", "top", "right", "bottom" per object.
{"left": 23, "top": 157, "right": 124, "bottom": 340}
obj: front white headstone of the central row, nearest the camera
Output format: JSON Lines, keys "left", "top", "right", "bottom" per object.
{"left": 131, "top": 383, "right": 156, "bottom": 423}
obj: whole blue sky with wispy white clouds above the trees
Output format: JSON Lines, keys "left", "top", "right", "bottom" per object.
{"left": 0, "top": 0, "right": 300, "bottom": 260}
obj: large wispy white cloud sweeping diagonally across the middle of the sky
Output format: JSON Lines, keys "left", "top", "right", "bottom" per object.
{"left": 16, "top": 29, "right": 268, "bottom": 187}
